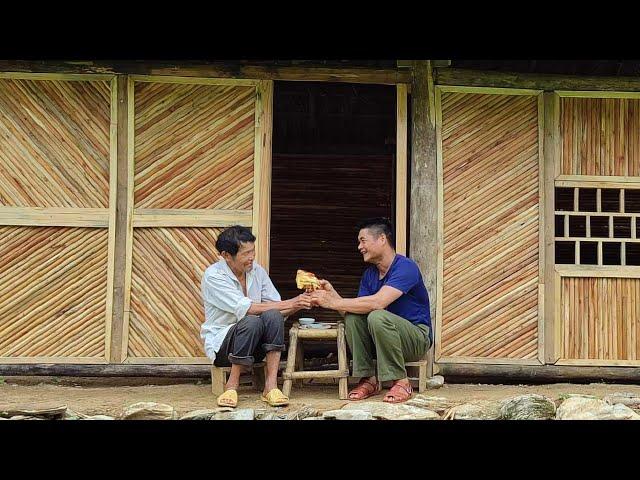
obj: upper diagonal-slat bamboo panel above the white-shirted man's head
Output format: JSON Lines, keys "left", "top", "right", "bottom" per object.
{"left": 134, "top": 82, "right": 256, "bottom": 210}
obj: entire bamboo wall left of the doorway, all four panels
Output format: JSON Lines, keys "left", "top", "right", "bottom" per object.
{"left": 0, "top": 74, "right": 272, "bottom": 363}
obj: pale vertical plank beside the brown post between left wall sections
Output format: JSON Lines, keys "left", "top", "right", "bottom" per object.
{"left": 120, "top": 78, "right": 135, "bottom": 362}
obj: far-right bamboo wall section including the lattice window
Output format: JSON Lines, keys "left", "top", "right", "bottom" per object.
{"left": 554, "top": 92, "right": 640, "bottom": 365}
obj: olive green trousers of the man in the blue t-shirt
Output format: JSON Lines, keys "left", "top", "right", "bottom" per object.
{"left": 344, "top": 310, "right": 430, "bottom": 382}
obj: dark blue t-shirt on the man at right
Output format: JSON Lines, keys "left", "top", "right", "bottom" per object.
{"left": 358, "top": 254, "right": 432, "bottom": 336}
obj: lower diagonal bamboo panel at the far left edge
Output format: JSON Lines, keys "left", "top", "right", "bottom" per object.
{"left": 0, "top": 227, "right": 108, "bottom": 362}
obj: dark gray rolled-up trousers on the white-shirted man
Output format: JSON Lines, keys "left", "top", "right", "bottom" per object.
{"left": 213, "top": 310, "right": 284, "bottom": 367}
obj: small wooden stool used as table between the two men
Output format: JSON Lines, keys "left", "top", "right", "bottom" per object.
{"left": 282, "top": 322, "right": 349, "bottom": 400}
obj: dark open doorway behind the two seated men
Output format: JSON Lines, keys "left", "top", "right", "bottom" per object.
{"left": 270, "top": 82, "right": 396, "bottom": 350}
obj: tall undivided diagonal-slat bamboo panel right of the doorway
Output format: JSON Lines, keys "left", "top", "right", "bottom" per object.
{"left": 441, "top": 93, "right": 539, "bottom": 359}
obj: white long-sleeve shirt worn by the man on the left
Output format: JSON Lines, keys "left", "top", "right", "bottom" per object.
{"left": 200, "top": 258, "right": 281, "bottom": 363}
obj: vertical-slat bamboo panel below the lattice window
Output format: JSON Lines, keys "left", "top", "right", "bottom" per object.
{"left": 560, "top": 277, "right": 640, "bottom": 360}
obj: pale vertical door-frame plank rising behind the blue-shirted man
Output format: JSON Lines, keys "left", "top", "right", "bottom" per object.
{"left": 395, "top": 85, "right": 407, "bottom": 255}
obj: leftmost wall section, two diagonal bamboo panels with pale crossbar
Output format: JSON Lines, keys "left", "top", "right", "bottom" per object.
{"left": 0, "top": 76, "right": 114, "bottom": 363}
